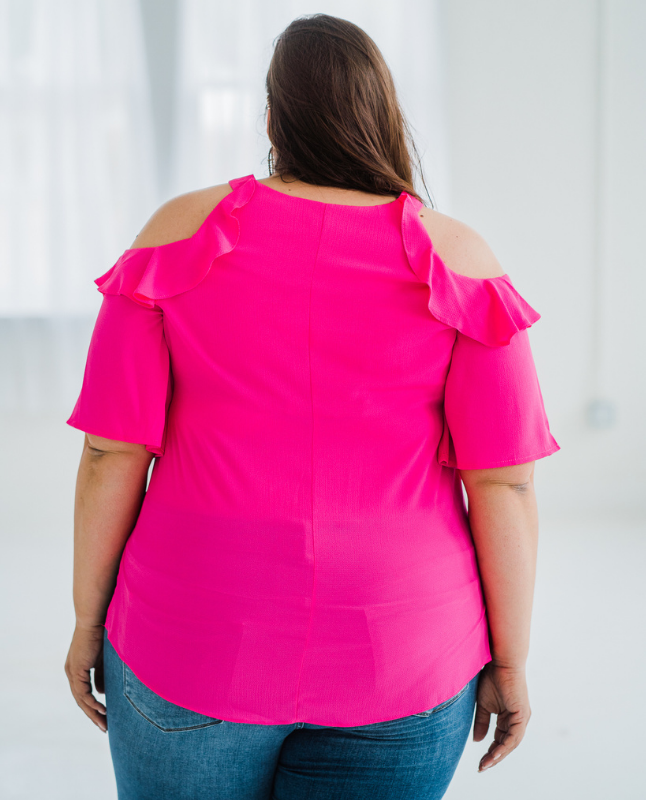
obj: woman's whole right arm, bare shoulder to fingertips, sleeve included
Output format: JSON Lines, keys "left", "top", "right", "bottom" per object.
{"left": 420, "top": 208, "right": 559, "bottom": 771}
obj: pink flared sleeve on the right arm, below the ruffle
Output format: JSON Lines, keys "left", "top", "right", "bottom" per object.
{"left": 438, "top": 329, "right": 560, "bottom": 469}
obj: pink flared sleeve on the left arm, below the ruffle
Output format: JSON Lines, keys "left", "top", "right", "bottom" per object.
{"left": 67, "top": 294, "right": 172, "bottom": 456}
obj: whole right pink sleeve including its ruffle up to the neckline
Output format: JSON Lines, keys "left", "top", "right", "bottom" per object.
{"left": 402, "top": 195, "right": 560, "bottom": 469}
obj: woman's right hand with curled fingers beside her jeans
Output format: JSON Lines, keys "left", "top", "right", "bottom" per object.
{"left": 473, "top": 661, "right": 532, "bottom": 772}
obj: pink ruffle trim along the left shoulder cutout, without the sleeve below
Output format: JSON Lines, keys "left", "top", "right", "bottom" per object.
{"left": 94, "top": 175, "right": 255, "bottom": 308}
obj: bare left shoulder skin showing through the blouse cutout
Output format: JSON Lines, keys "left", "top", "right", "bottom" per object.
{"left": 131, "top": 183, "right": 233, "bottom": 249}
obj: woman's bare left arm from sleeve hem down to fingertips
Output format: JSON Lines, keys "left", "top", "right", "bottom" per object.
{"left": 65, "top": 434, "right": 153, "bottom": 731}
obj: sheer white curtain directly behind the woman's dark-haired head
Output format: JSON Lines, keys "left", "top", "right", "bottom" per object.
{"left": 170, "top": 0, "right": 450, "bottom": 211}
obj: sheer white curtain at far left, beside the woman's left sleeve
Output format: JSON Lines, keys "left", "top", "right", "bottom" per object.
{"left": 0, "top": 0, "right": 158, "bottom": 410}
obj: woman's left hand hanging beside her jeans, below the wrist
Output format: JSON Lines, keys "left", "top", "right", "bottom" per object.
{"left": 65, "top": 623, "right": 108, "bottom": 733}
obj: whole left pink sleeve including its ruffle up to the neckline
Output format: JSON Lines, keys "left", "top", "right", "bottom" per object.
{"left": 67, "top": 175, "right": 255, "bottom": 456}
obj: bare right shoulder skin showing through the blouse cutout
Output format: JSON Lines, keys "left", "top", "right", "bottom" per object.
{"left": 419, "top": 208, "right": 505, "bottom": 278}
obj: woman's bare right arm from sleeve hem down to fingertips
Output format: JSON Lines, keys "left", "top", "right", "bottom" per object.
{"left": 460, "top": 461, "right": 538, "bottom": 771}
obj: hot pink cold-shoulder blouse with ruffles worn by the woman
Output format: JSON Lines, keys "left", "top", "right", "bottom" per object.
{"left": 68, "top": 175, "right": 559, "bottom": 726}
